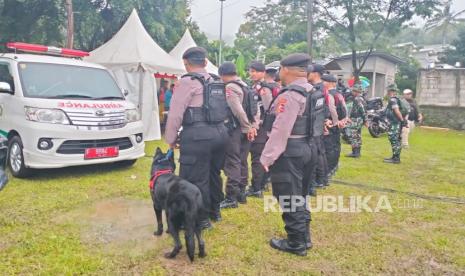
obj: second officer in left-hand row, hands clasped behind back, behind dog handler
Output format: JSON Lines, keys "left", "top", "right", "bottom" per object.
{"left": 218, "top": 62, "right": 260, "bottom": 208}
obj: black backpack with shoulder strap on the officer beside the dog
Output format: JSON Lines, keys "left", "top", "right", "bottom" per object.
{"left": 182, "top": 73, "right": 229, "bottom": 124}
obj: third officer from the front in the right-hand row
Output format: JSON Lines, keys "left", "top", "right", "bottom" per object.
{"left": 321, "top": 74, "right": 347, "bottom": 176}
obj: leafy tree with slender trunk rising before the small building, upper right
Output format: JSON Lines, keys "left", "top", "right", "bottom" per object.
{"left": 317, "top": 0, "right": 438, "bottom": 79}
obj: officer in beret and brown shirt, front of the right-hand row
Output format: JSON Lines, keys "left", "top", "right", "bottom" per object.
{"left": 260, "top": 54, "right": 312, "bottom": 256}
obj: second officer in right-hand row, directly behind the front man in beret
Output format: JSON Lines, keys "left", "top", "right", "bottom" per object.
{"left": 308, "top": 64, "right": 328, "bottom": 188}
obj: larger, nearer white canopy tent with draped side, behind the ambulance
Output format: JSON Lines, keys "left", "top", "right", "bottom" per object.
{"left": 86, "top": 10, "right": 185, "bottom": 141}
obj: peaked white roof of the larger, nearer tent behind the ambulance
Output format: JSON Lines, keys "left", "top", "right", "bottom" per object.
{"left": 86, "top": 9, "right": 184, "bottom": 74}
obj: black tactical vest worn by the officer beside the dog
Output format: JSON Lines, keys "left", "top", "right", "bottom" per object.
{"left": 182, "top": 73, "right": 229, "bottom": 125}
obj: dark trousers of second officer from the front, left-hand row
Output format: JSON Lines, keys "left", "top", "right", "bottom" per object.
{"left": 224, "top": 127, "right": 250, "bottom": 200}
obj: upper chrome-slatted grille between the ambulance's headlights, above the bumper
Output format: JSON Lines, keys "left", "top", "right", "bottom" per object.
{"left": 66, "top": 111, "right": 127, "bottom": 128}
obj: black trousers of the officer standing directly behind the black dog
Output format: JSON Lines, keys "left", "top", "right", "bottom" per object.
{"left": 179, "top": 123, "right": 228, "bottom": 219}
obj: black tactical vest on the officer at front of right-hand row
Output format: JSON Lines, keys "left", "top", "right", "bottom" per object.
{"left": 263, "top": 85, "right": 311, "bottom": 136}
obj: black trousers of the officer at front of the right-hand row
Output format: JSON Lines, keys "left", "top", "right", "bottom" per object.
{"left": 270, "top": 138, "right": 314, "bottom": 242}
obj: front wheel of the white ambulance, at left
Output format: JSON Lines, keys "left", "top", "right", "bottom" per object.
{"left": 7, "top": 136, "right": 31, "bottom": 178}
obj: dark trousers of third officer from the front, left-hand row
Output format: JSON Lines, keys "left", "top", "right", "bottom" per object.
{"left": 250, "top": 127, "right": 268, "bottom": 191}
